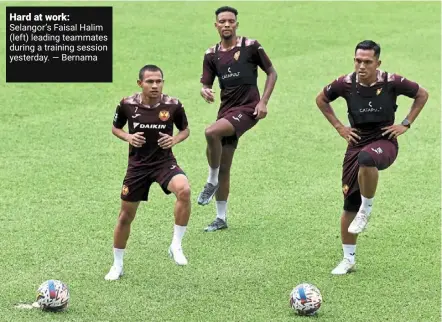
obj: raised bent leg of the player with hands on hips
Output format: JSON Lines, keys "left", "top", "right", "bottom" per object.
{"left": 348, "top": 140, "right": 397, "bottom": 234}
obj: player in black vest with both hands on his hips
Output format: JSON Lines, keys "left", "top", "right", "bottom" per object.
{"left": 316, "top": 40, "right": 428, "bottom": 275}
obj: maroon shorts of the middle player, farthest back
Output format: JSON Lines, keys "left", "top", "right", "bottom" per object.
{"left": 218, "top": 107, "right": 258, "bottom": 148}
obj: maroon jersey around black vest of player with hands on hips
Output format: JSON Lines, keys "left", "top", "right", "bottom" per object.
{"left": 323, "top": 70, "right": 419, "bottom": 146}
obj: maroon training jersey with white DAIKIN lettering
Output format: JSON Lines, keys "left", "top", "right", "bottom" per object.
{"left": 113, "top": 93, "right": 188, "bottom": 167}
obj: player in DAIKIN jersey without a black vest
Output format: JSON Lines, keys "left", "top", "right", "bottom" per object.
{"left": 105, "top": 65, "right": 191, "bottom": 280}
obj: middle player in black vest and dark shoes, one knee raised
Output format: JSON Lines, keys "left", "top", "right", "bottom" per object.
{"left": 198, "top": 7, "right": 277, "bottom": 231}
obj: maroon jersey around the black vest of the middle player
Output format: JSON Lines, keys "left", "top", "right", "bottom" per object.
{"left": 201, "top": 37, "right": 272, "bottom": 114}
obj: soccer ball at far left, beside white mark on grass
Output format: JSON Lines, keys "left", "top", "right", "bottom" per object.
{"left": 37, "top": 280, "right": 70, "bottom": 312}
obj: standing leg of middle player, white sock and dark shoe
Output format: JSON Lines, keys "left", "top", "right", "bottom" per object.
{"left": 204, "top": 143, "right": 236, "bottom": 231}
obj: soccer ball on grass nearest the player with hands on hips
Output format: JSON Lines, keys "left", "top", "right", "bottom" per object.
{"left": 290, "top": 283, "right": 322, "bottom": 315}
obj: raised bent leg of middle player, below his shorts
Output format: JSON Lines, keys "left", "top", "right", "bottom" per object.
{"left": 198, "top": 118, "right": 235, "bottom": 206}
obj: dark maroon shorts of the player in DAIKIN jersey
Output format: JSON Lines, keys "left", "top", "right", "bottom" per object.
{"left": 121, "top": 162, "right": 185, "bottom": 202}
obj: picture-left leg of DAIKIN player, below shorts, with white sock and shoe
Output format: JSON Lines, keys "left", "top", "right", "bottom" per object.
{"left": 105, "top": 200, "right": 140, "bottom": 280}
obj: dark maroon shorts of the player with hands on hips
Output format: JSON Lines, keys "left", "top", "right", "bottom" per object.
{"left": 342, "top": 140, "right": 398, "bottom": 212}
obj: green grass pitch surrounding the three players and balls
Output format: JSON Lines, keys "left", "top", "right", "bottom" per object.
{"left": 0, "top": 1, "right": 441, "bottom": 321}
